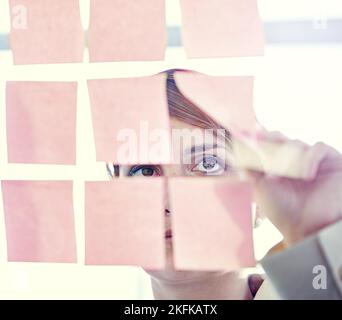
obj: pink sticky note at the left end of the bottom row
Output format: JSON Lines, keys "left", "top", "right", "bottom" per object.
{"left": 1, "top": 181, "right": 76, "bottom": 263}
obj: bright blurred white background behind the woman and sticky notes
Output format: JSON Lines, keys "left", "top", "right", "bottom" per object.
{"left": 0, "top": 0, "right": 342, "bottom": 299}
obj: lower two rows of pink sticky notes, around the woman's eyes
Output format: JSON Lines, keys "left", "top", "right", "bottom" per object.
{"left": 1, "top": 71, "right": 256, "bottom": 270}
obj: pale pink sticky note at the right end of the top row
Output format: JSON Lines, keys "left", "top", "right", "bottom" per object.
{"left": 180, "top": 0, "right": 265, "bottom": 58}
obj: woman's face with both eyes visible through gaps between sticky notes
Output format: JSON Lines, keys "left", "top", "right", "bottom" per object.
{"left": 120, "top": 118, "right": 232, "bottom": 278}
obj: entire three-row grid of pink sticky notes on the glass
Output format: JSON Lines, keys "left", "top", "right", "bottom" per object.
{"left": 0, "top": 0, "right": 264, "bottom": 270}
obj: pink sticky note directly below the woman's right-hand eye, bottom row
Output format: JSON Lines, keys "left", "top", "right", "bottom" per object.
{"left": 169, "top": 178, "right": 255, "bottom": 270}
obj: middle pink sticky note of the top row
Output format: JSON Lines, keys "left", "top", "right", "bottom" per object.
{"left": 89, "top": 0, "right": 167, "bottom": 62}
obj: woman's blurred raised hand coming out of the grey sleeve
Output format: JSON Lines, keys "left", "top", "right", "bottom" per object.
{"left": 248, "top": 133, "right": 342, "bottom": 244}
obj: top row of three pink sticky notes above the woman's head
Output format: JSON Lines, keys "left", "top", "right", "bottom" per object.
{"left": 9, "top": 0, "right": 264, "bottom": 64}
